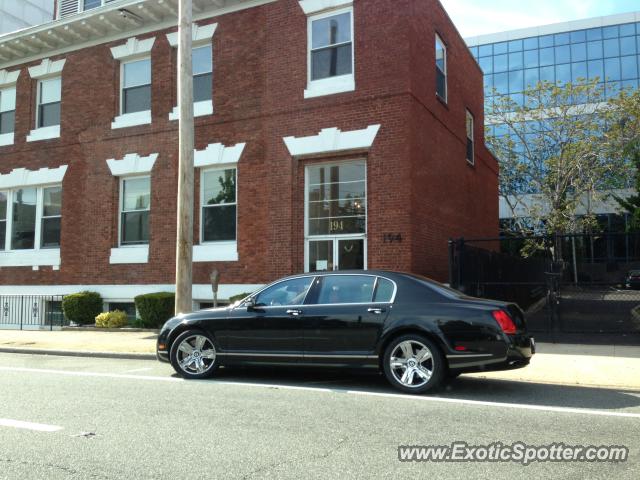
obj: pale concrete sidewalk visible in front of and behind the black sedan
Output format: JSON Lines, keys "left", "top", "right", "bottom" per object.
{"left": 0, "top": 330, "right": 640, "bottom": 391}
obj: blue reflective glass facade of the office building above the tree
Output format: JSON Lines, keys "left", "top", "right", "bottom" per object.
{"left": 471, "top": 23, "right": 640, "bottom": 114}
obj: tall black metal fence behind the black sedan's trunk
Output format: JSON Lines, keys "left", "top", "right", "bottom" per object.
{"left": 449, "top": 234, "right": 640, "bottom": 343}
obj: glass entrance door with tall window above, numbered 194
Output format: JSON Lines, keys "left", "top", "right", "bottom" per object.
{"left": 305, "top": 160, "right": 367, "bottom": 272}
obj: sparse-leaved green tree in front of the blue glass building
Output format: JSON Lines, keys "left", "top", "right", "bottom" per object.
{"left": 487, "top": 79, "right": 629, "bottom": 255}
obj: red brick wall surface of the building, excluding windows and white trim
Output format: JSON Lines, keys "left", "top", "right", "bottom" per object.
{"left": 0, "top": 0, "right": 498, "bottom": 285}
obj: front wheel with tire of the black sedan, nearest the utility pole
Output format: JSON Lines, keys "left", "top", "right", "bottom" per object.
{"left": 169, "top": 330, "right": 219, "bottom": 379}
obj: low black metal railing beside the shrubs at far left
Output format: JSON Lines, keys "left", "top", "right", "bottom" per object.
{"left": 0, "top": 295, "right": 68, "bottom": 330}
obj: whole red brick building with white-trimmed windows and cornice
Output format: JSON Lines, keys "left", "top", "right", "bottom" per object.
{"left": 0, "top": 0, "right": 498, "bottom": 312}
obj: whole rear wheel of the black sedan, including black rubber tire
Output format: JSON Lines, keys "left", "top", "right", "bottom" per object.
{"left": 383, "top": 333, "right": 447, "bottom": 394}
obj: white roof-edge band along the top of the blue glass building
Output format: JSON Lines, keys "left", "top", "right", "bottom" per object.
{"left": 465, "top": 11, "right": 640, "bottom": 47}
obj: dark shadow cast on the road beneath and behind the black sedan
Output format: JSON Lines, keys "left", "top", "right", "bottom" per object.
{"left": 190, "top": 367, "right": 640, "bottom": 410}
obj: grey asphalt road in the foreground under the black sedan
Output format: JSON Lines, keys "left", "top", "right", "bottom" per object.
{"left": 0, "top": 354, "right": 640, "bottom": 479}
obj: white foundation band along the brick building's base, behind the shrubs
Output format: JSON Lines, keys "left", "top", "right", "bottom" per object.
{"left": 0, "top": 283, "right": 264, "bottom": 301}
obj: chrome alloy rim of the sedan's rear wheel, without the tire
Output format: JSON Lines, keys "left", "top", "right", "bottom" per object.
{"left": 389, "top": 340, "right": 434, "bottom": 388}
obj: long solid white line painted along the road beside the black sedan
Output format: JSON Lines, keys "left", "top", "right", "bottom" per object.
{"left": 0, "top": 366, "right": 640, "bottom": 419}
